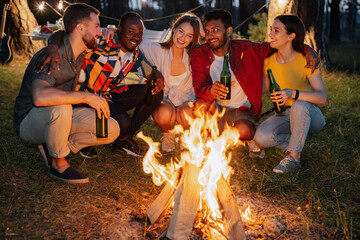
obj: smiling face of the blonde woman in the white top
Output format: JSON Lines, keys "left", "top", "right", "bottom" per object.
{"left": 173, "top": 22, "right": 194, "bottom": 49}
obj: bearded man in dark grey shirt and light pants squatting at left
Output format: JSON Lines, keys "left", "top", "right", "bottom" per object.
{"left": 13, "top": 3, "right": 120, "bottom": 183}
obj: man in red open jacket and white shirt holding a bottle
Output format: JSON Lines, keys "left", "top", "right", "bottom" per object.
{"left": 190, "top": 9, "right": 319, "bottom": 148}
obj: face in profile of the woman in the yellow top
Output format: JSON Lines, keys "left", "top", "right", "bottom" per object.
{"left": 269, "top": 19, "right": 295, "bottom": 49}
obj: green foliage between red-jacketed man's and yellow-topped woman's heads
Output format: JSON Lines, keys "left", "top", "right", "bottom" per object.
{"left": 247, "top": 12, "right": 268, "bottom": 42}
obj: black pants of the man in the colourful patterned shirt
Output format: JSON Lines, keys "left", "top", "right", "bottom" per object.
{"left": 109, "top": 84, "right": 164, "bottom": 141}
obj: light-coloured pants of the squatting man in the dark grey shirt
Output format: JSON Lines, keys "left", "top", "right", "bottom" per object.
{"left": 20, "top": 105, "right": 120, "bottom": 158}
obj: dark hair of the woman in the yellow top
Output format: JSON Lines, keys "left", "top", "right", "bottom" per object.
{"left": 274, "top": 15, "right": 305, "bottom": 53}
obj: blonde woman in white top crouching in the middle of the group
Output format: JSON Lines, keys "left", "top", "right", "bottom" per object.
{"left": 140, "top": 13, "right": 203, "bottom": 152}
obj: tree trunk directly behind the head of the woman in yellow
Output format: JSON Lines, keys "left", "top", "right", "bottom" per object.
{"left": 266, "top": 0, "right": 332, "bottom": 69}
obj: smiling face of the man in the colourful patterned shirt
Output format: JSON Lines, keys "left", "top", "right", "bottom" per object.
{"left": 117, "top": 17, "right": 144, "bottom": 52}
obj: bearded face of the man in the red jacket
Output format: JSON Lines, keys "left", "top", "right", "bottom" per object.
{"left": 204, "top": 19, "right": 232, "bottom": 51}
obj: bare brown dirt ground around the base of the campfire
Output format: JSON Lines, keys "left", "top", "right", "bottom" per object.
{"left": 19, "top": 188, "right": 329, "bottom": 240}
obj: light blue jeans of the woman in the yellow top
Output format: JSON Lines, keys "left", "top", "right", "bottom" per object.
{"left": 254, "top": 100, "right": 325, "bottom": 152}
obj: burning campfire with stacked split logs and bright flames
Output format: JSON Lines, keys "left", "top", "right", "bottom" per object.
{"left": 138, "top": 109, "right": 250, "bottom": 240}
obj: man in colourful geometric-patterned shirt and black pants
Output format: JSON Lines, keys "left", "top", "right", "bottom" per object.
{"left": 34, "top": 12, "right": 164, "bottom": 157}
